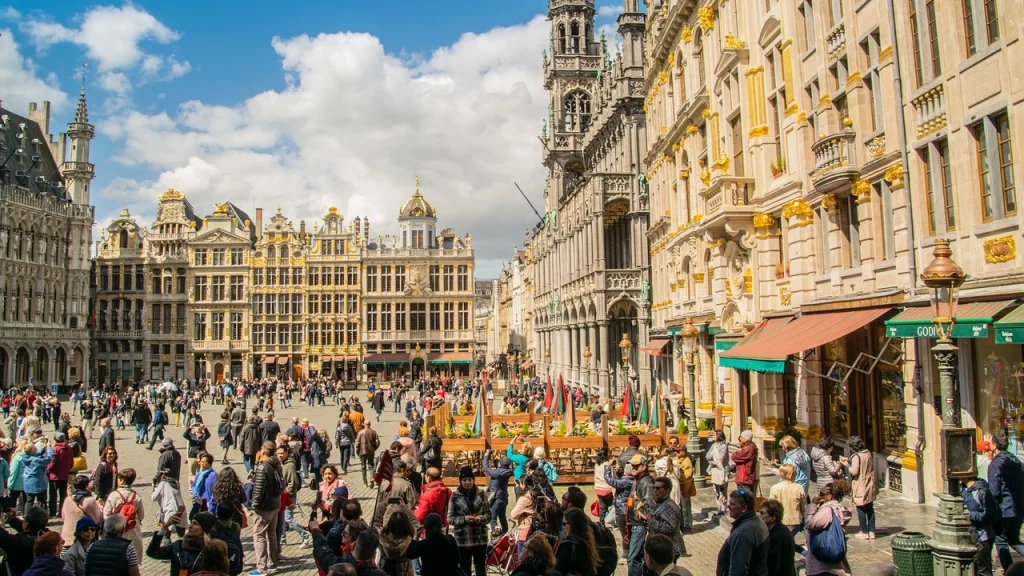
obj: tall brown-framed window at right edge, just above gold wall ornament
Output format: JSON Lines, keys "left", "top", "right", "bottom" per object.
{"left": 973, "top": 112, "right": 1017, "bottom": 220}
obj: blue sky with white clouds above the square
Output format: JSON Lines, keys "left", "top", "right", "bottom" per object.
{"left": 0, "top": 0, "right": 622, "bottom": 279}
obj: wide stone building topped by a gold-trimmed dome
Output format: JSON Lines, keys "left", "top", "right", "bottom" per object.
{"left": 361, "top": 176, "right": 475, "bottom": 378}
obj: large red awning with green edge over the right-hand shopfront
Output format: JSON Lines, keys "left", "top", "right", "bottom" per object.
{"left": 719, "top": 307, "right": 892, "bottom": 374}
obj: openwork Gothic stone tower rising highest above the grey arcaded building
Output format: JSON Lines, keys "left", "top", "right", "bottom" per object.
{"left": 542, "top": 0, "right": 604, "bottom": 211}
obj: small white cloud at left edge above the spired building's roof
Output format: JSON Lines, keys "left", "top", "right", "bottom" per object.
{"left": 0, "top": 29, "right": 70, "bottom": 114}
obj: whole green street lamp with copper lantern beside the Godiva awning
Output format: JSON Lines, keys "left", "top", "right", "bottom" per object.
{"left": 921, "top": 239, "right": 977, "bottom": 574}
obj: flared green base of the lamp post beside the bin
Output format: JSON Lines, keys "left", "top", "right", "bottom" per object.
{"left": 928, "top": 493, "right": 978, "bottom": 576}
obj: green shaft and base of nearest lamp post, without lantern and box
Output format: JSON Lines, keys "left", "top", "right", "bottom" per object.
{"left": 929, "top": 338, "right": 978, "bottom": 576}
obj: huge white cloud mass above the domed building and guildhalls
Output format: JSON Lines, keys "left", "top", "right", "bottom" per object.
{"left": 98, "top": 16, "right": 549, "bottom": 270}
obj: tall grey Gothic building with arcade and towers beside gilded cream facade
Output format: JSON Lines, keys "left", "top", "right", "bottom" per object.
{"left": 529, "top": 0, "right": 650, "bottom": 396}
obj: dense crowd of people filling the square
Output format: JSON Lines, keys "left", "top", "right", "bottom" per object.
{"left": 0, "top": 379, "right": 1024, "bottom": 576}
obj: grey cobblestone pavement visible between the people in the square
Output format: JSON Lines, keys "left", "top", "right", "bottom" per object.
{"left": 51, "top": 390, "right": 935, "bottom": 576}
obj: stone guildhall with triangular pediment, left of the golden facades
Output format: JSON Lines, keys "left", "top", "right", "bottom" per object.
{"left": 185, "top": 202, "right": 254, "bottom": 381}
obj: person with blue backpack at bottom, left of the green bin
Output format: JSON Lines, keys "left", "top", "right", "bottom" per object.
{"left": 802, "top": 480, "right": 852, "bottom": 576}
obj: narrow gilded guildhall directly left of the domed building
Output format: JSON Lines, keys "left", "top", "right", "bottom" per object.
{"left": 306, "top": 208, "right": 370, "bottom": 380}
